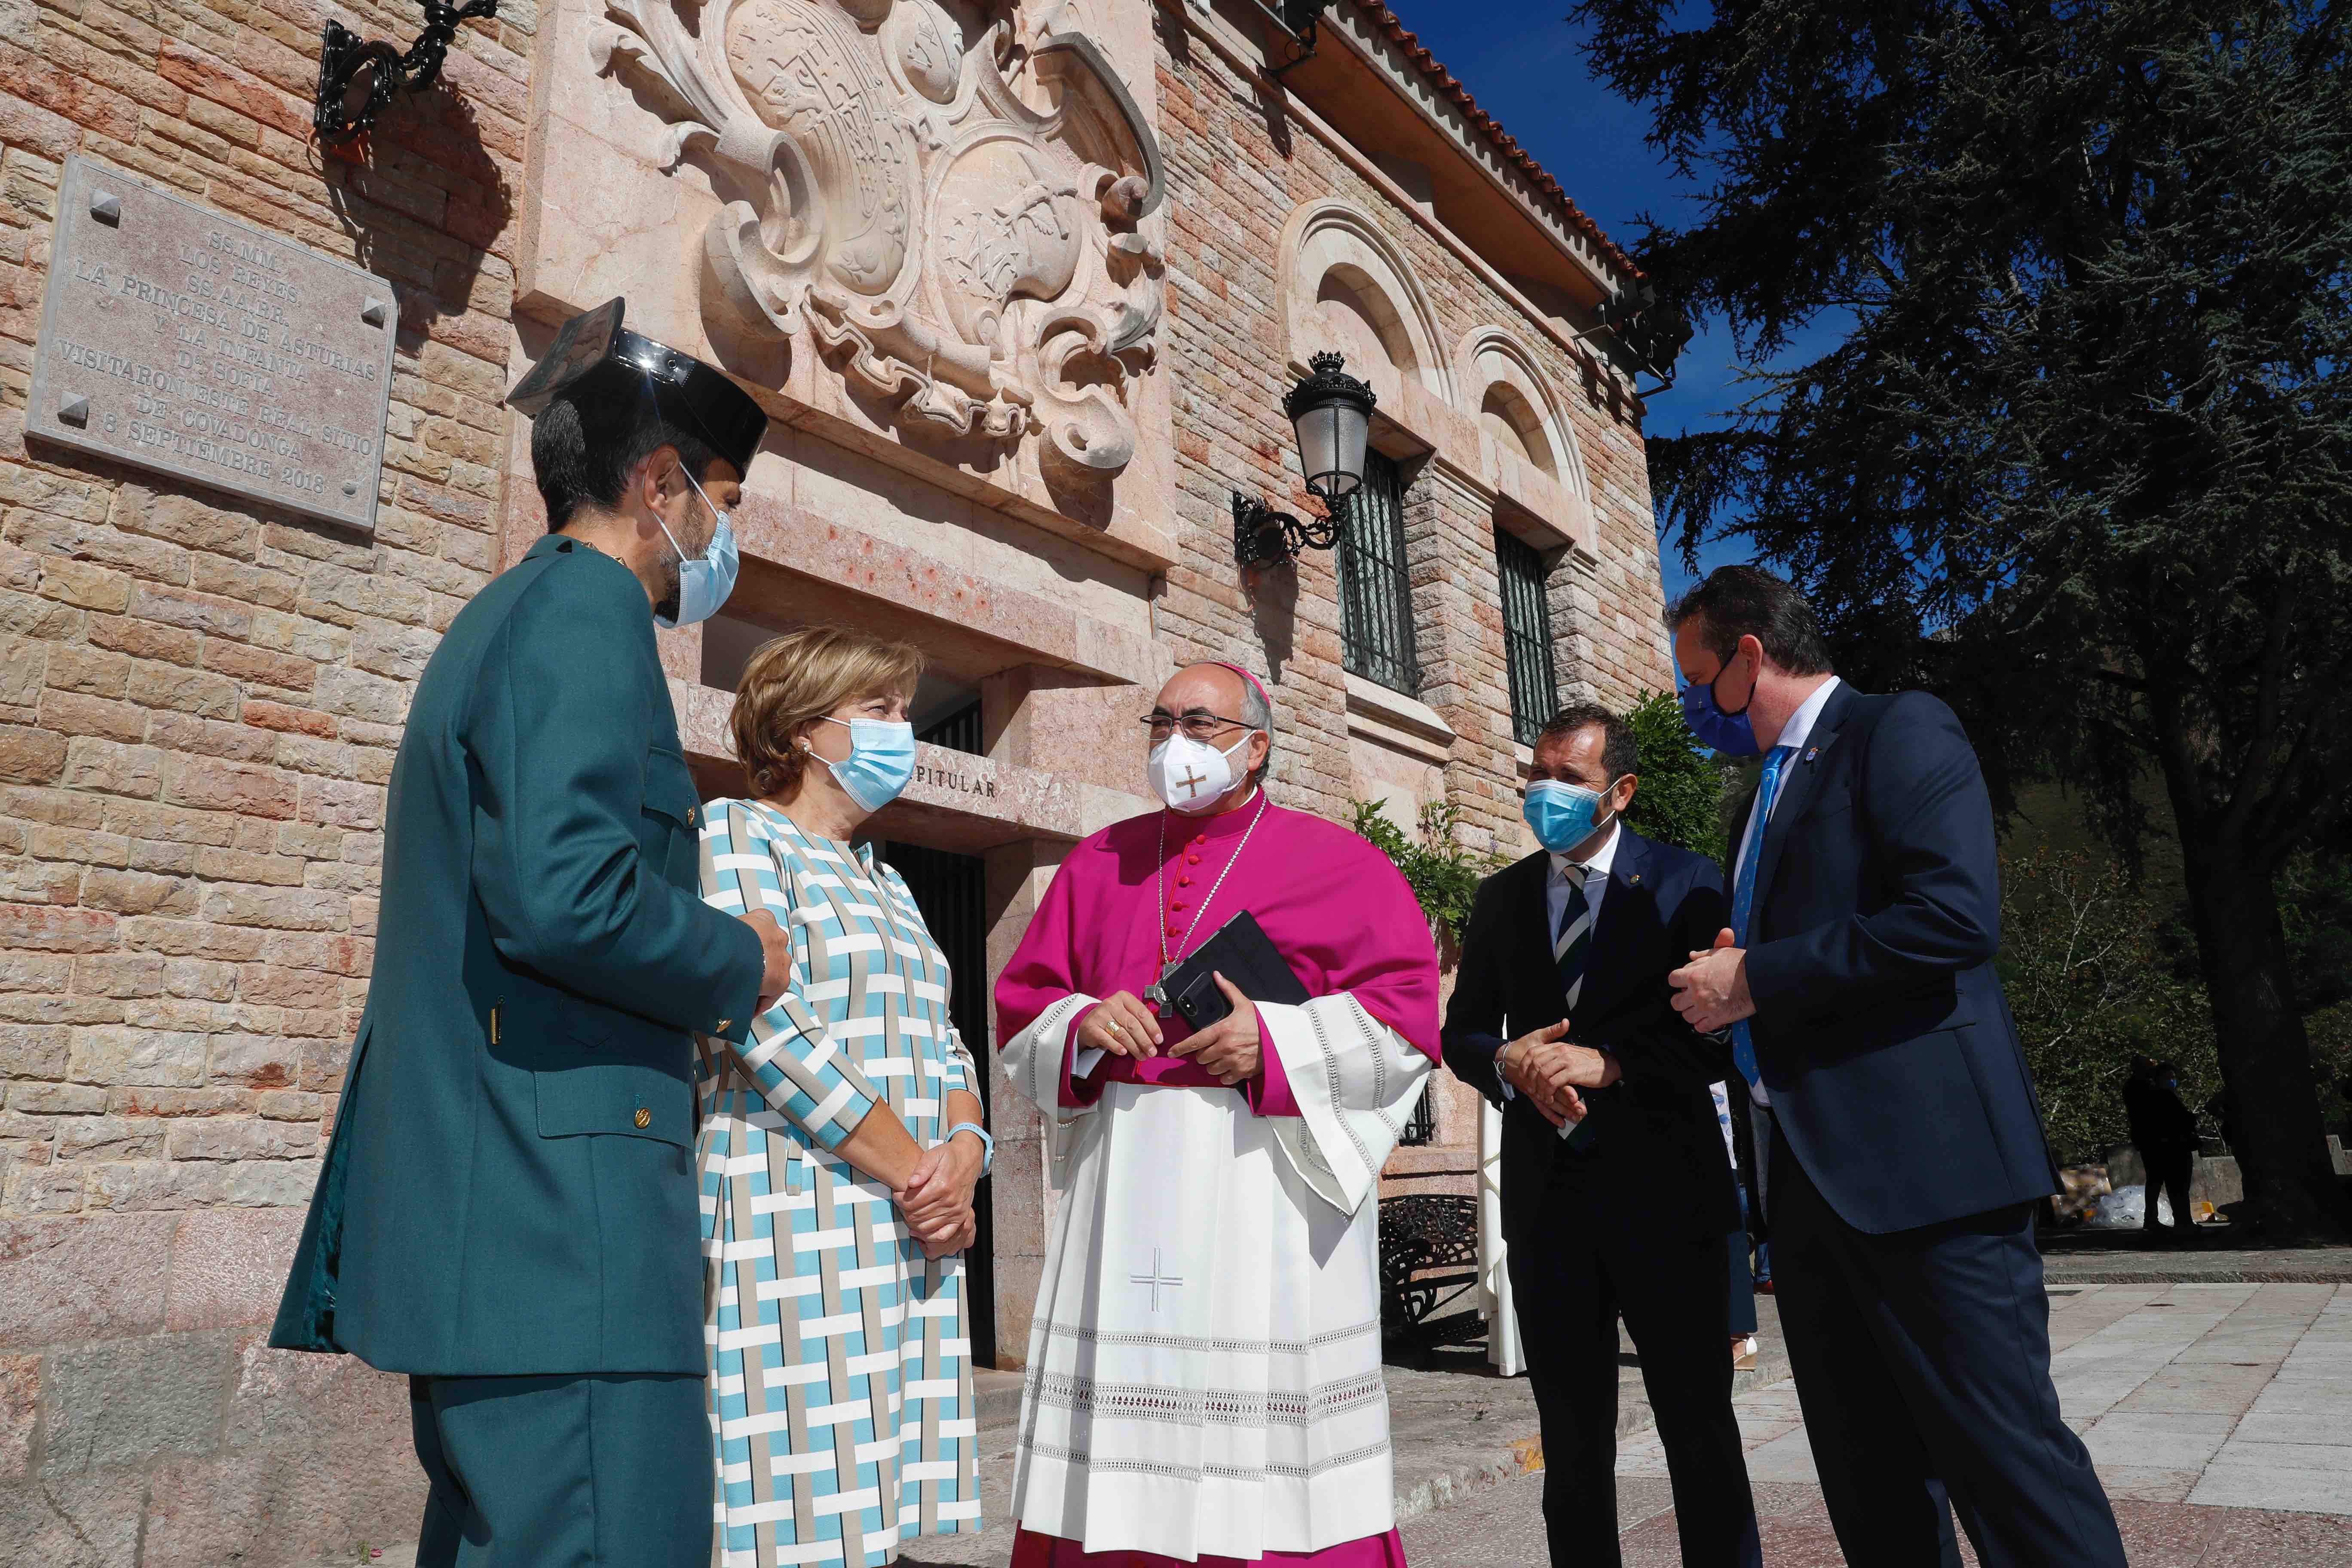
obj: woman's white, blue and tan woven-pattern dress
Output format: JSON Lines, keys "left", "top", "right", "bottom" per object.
{"left": 696, "top": 799, "right": 981, "bottom": 1568}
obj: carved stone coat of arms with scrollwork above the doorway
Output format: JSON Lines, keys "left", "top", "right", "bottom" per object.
{"left": 590, "top": 0, "right": 1164, "bottom": 477}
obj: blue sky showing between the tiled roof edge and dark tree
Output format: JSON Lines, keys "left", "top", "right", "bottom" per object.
{"left": 1390, "top": 0, "right": 1750, "bottom": 595}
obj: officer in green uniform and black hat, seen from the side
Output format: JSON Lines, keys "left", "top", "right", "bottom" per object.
{"left": 270, "top": 301, "right": 790, "bottom": 1568}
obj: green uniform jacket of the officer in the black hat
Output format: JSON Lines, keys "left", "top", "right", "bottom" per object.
{"left": 270, "top": 534, "right": 762, "bottom": 1375}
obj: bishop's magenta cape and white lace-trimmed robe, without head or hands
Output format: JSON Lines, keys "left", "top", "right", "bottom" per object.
{"left": 997, "top": 790, "right": 1439, "bottom": 1568}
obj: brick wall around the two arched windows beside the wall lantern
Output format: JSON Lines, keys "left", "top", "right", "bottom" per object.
{"left": 1157, "top": 12, "right": 1672, "bottom": 851}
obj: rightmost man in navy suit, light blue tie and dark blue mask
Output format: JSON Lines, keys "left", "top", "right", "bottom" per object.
{"left": 1668, "top": 567, "right": 2124, "bottom": 1568}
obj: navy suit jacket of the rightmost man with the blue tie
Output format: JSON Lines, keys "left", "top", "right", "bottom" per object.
{"left": 1731, "top": 684, "right": 2058, "bottom": 1234}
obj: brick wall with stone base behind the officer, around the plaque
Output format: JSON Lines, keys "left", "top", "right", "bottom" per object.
{"left": 0, "top": 0, "right": 534, "bottom": 1568}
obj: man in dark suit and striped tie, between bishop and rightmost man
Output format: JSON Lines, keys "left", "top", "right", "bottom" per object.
{"left": 1444, "top": 703, "right": 1762, "bottom": 1568}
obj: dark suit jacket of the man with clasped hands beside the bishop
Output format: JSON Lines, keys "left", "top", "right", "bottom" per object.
{"left": 1444, "top": 827, "right": 1740, "bottom": 1239}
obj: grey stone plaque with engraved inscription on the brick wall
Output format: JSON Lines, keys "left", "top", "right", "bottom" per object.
{"left": 24, "top": 155, "right": 400, "bottom": 529}
